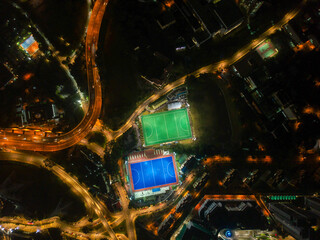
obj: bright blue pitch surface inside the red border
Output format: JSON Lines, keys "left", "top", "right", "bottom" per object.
{"left": 129, "top": 156, "right": 178, "bottom": 191}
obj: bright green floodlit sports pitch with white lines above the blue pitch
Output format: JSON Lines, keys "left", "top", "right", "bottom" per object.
{"left": 141, "top": 108, "right": 192, "bottom": 146}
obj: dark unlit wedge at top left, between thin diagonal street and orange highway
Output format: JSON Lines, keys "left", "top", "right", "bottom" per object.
{"left": 22, "top": 0, "right": 89, "bottom": 55}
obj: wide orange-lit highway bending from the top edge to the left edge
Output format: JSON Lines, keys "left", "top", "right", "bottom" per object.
{"left": 0, "top": 0, "right": 108, "bottom": 151}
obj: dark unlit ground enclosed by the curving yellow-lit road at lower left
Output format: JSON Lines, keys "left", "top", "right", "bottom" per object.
{"left": 0, "top": 162, "right": 86, "bottom": 221}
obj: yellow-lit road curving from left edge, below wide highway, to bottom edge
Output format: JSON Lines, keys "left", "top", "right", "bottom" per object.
{"left": 0, "top": 151, "right": 117, "bottom": 239}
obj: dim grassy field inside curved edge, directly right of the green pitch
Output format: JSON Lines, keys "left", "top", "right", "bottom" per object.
{"left": 187, "top": 75, "right": 232, "bottom": 152}
